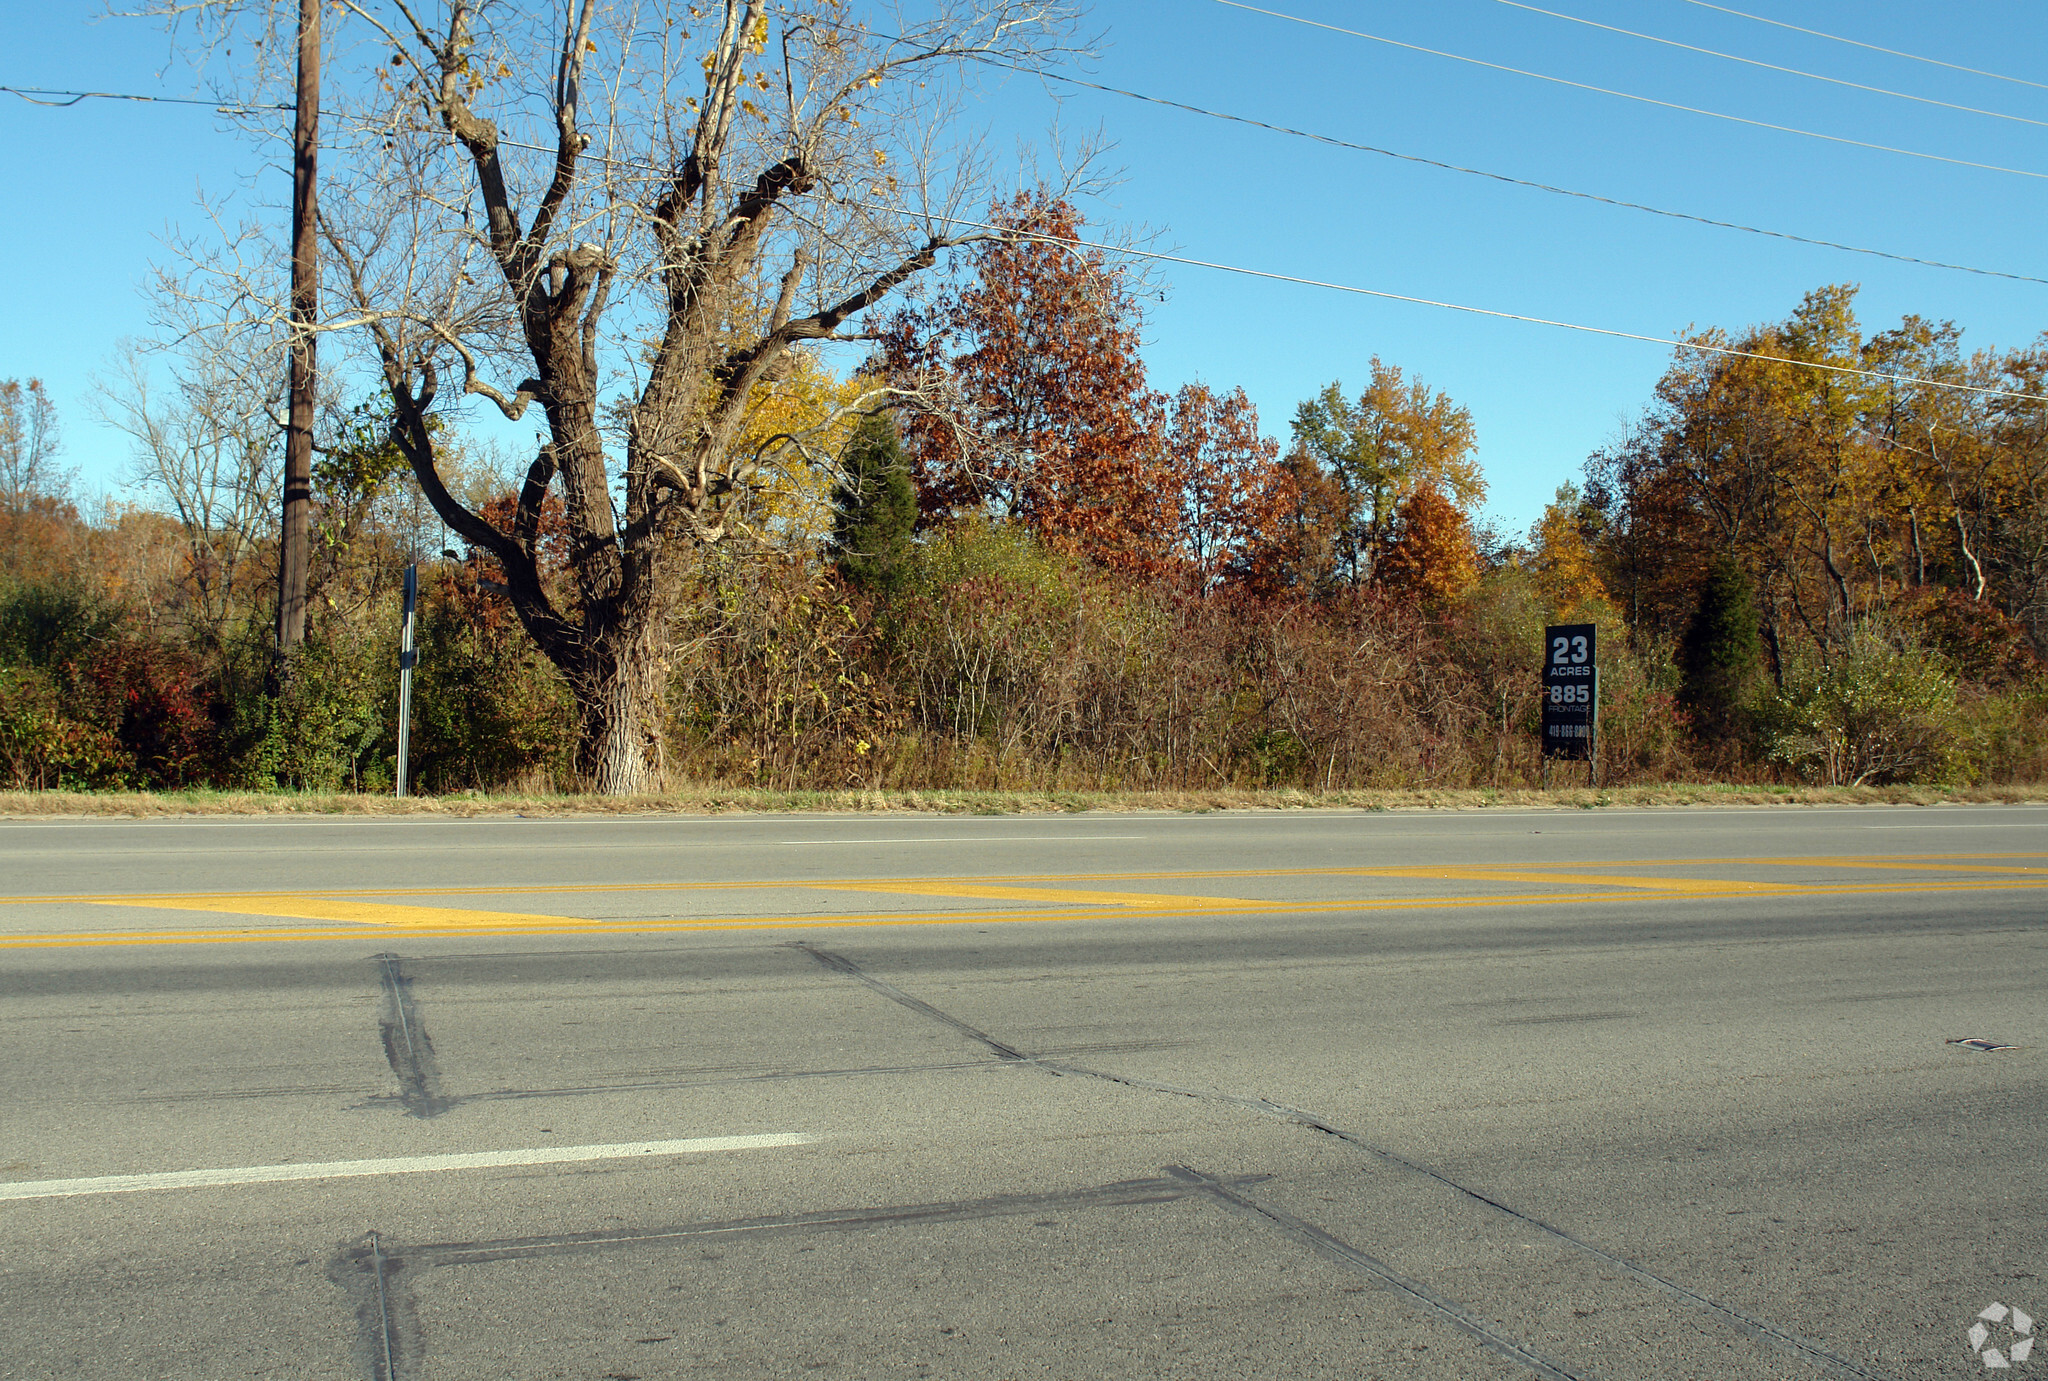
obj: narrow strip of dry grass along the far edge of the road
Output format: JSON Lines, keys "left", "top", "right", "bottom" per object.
{"left": 0, "top": 783, "right": 2048, "bottom": 818}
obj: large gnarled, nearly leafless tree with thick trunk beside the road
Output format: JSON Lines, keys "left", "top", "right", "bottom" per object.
{"left": 160, "top": 0, "right": 1069, "bottom": 793}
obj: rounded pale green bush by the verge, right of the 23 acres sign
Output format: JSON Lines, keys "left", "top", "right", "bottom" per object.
{"left": 1759, "top": 621, "right": 1970, "bottom": 787}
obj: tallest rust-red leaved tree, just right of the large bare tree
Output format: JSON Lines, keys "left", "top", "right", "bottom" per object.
{"left": 881, "top": 189, "right": 1180, "bottom": 572}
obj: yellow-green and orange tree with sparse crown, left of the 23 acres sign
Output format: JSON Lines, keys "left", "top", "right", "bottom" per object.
{"left": 1294, "top": 357, "right": 1487, "bottom": 584}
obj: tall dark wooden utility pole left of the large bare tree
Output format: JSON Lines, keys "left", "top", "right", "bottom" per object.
{"left": 276, "top": 0, "right": 319, "bottom": 654}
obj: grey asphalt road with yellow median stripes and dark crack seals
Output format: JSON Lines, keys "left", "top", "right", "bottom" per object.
{"left": 0, "top": 794, "right": 2048, "bottom": 1381}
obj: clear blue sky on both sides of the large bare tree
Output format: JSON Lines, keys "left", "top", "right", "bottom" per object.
{"left": 0, "top": 0, "right": 2048, "bottom": 529}
